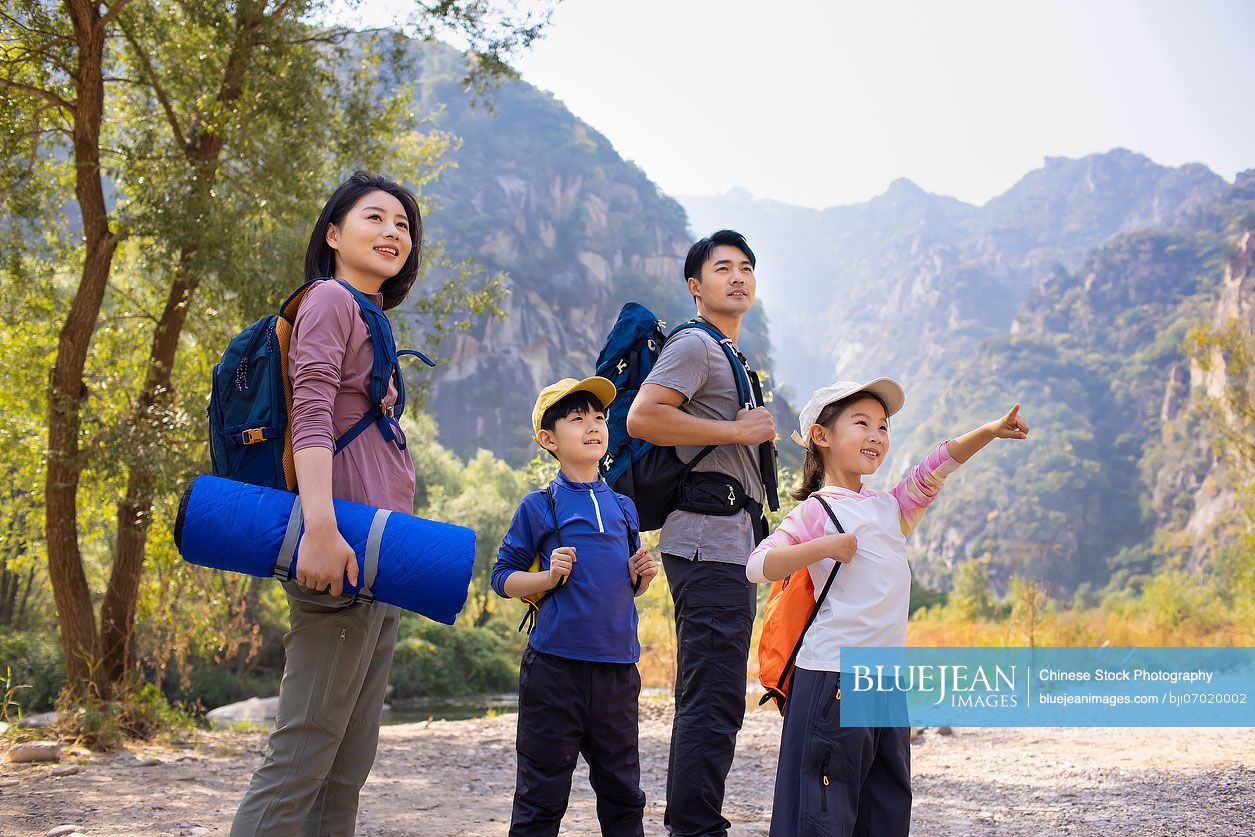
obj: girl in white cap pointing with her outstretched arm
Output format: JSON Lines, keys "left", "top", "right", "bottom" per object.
{"left": 745, "top": 378, "right": 1028, "bottom": 837}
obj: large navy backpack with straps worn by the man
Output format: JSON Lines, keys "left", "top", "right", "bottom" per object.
{"left": 596, "top": 302, "right": 779, "bottom": 531}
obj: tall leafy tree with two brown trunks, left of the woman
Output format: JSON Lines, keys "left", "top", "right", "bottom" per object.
{"left": 0, "top": 0, "right": 541, "bottom": 696}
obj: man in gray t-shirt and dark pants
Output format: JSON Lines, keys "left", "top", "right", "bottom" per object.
{"left": 628, "top": 230, "right": 776, "bottom": 837}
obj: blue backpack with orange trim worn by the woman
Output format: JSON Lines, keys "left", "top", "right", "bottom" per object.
{"left": 208, "top": 279, "right": 435, "bottom": 491}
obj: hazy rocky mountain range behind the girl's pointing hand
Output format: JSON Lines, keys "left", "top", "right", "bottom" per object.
{"left": 684, "top": 151, "right": 1255, "bottom": 592}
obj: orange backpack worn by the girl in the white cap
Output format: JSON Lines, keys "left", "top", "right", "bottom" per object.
{"left": 758, "top": 497, "right": 845, "bottom": 715}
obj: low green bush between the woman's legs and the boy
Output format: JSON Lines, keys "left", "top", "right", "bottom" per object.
{"left": 389, "top": 615, "right": 526, "bottom": 700}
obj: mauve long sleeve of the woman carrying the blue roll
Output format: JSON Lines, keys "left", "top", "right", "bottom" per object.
{"left": 287, "top": 282, "right": 358, "bottom": 450}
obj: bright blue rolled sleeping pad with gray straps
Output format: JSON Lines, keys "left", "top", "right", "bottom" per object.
{"left": 174, "top": 474, "right": 474, "bottom": 625}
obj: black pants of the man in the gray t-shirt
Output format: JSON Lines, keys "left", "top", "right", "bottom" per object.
{"left": 663, "top": 555, "right": 757, "bottom": 837}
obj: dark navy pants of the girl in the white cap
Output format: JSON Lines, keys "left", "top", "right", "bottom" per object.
{"left": 771, "top": 668, "right": 911, "bottom": 837}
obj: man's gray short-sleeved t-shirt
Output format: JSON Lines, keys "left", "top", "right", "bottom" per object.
{"left": 645, "top": 329, "right": 766, "bottom": 565}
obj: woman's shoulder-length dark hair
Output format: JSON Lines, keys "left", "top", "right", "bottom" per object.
{"left": 305, "top": 172, "right": 423, "bottom": 310}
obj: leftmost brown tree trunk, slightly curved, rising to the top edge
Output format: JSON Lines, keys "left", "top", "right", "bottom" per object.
{"left": 44, "top": 0, "right": 118, "bottom": 696}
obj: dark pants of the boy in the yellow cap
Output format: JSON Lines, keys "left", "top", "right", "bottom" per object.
{"left": 510, "top": 646, "right": 645, "bottom": 837}
